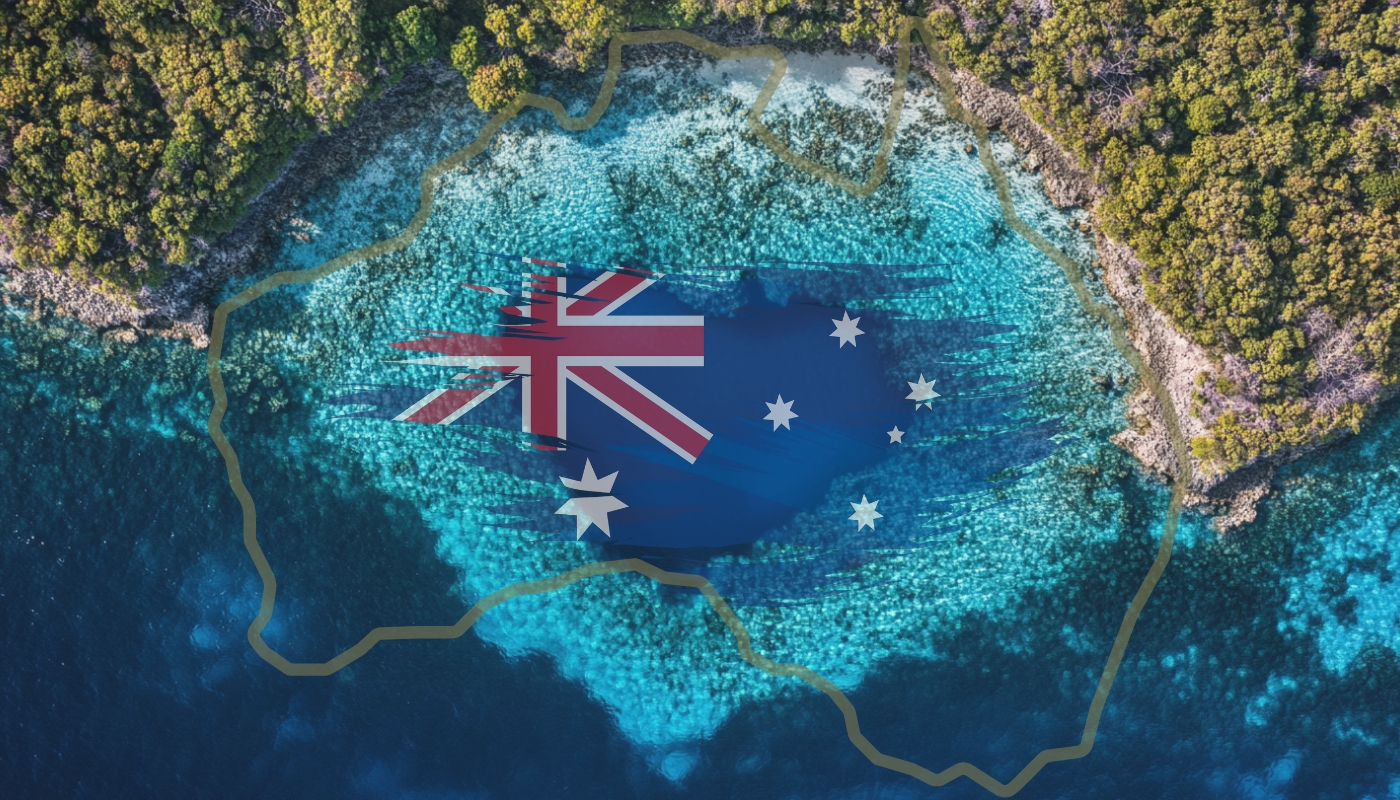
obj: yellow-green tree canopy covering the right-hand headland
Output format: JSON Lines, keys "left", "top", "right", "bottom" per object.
{"left": 932, "top": 0, "right": 1400, "bottom": 467}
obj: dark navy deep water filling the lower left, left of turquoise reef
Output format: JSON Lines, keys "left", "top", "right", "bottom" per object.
{"left": 0, "top": 372, "right": 661, "bottom": 799}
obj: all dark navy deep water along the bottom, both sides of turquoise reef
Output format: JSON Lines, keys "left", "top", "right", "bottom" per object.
{"left": 13, "top": 315, "right": 1400, "bottom": 800}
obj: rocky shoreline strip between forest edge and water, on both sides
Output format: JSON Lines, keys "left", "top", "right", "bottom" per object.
{"left": 0, "top": 34, "right": 1301, "bottom": 531}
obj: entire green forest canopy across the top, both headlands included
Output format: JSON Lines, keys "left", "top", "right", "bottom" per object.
{"left": 0, "top": 0, "right": 1400, "bottom": 468}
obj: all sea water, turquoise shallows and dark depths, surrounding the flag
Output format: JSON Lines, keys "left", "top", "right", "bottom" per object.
{"left": 8, "top": 56, "right": 1400, "bottom": 799}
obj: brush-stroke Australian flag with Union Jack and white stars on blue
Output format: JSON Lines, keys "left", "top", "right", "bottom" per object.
{"left": 333, "top": 256, "right": 1060, "bottom": 602}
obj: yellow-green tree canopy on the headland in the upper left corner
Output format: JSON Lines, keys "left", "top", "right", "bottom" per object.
{"left": 0, "top": 0, "right": 484, "bottom": 291}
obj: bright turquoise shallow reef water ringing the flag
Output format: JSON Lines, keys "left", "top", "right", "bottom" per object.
{"left": 215, "top": 54, "right": 1151, "bottom": 756}
